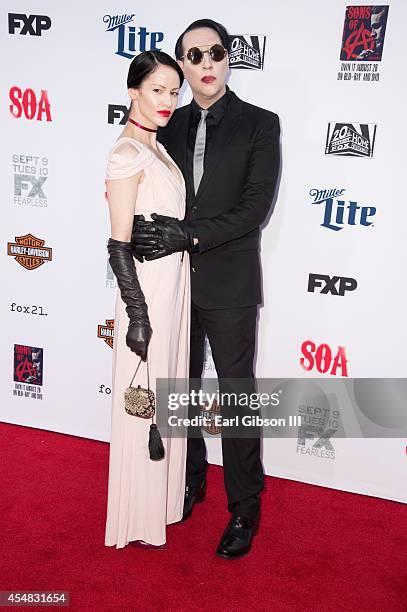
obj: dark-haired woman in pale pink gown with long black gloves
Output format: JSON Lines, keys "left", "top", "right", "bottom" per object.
{"left": 105, "top": 51, "right": 190, "bottom": 548}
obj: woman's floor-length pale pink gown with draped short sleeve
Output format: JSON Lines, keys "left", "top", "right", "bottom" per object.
{"left": 105, "top": 138, "right": 190, "bottom": 548}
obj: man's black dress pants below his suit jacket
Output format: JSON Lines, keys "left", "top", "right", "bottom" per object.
{"left": 186, "top": 302, "right": 264, "bottom": 518}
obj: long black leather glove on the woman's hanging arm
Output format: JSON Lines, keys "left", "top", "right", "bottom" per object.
{"left": 107, "top": 238, "right": 152, "bottom": 360}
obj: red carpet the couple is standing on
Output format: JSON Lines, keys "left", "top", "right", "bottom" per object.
{"left": 0, "top": 424, "right": 407, "bottom": 612}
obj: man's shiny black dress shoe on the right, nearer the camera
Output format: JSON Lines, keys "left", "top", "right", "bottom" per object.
{"left": 216, "top": 514, "right": 257, "bottom": 559}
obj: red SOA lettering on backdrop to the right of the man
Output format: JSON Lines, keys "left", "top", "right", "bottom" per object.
{"left": 300, "top": 340, "right": 348, "bottom": 377}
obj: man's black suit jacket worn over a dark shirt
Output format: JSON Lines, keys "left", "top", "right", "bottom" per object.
{"left": 158, "top": 93, "right": 280, "bottom": 309}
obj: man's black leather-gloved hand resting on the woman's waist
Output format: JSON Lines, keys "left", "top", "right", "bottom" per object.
{"left": 131, "top": 213, "right": 194, "bottom": 261}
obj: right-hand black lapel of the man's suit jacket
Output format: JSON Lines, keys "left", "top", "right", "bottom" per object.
{"left": 196, "top": 93, "right": 242, "bottom": 199}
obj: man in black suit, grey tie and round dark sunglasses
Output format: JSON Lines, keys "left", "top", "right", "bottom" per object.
{"left": 133, "top": 19, "right": 280, "bottom": 558}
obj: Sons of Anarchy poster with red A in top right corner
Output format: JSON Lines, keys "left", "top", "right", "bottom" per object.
{"left": 338, "top": 5, "right": 389, "bottom": 82}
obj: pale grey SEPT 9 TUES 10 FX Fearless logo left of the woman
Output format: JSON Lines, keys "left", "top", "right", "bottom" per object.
{"left": 13, "top": 153, "right": 48, "bottom": 208}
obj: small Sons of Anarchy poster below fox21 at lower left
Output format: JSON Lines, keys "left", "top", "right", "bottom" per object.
{"left": 13, "top": 344, "right": 44, "bottom": 400}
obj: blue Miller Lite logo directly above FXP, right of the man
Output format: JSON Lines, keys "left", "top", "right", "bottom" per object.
{"left": 309, "top": 188, "right": 376, "bottom": 232}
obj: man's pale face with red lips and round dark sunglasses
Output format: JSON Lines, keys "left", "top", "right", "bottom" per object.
{"left": 178, "top": 28, "right": 229, "bottom": 106}
